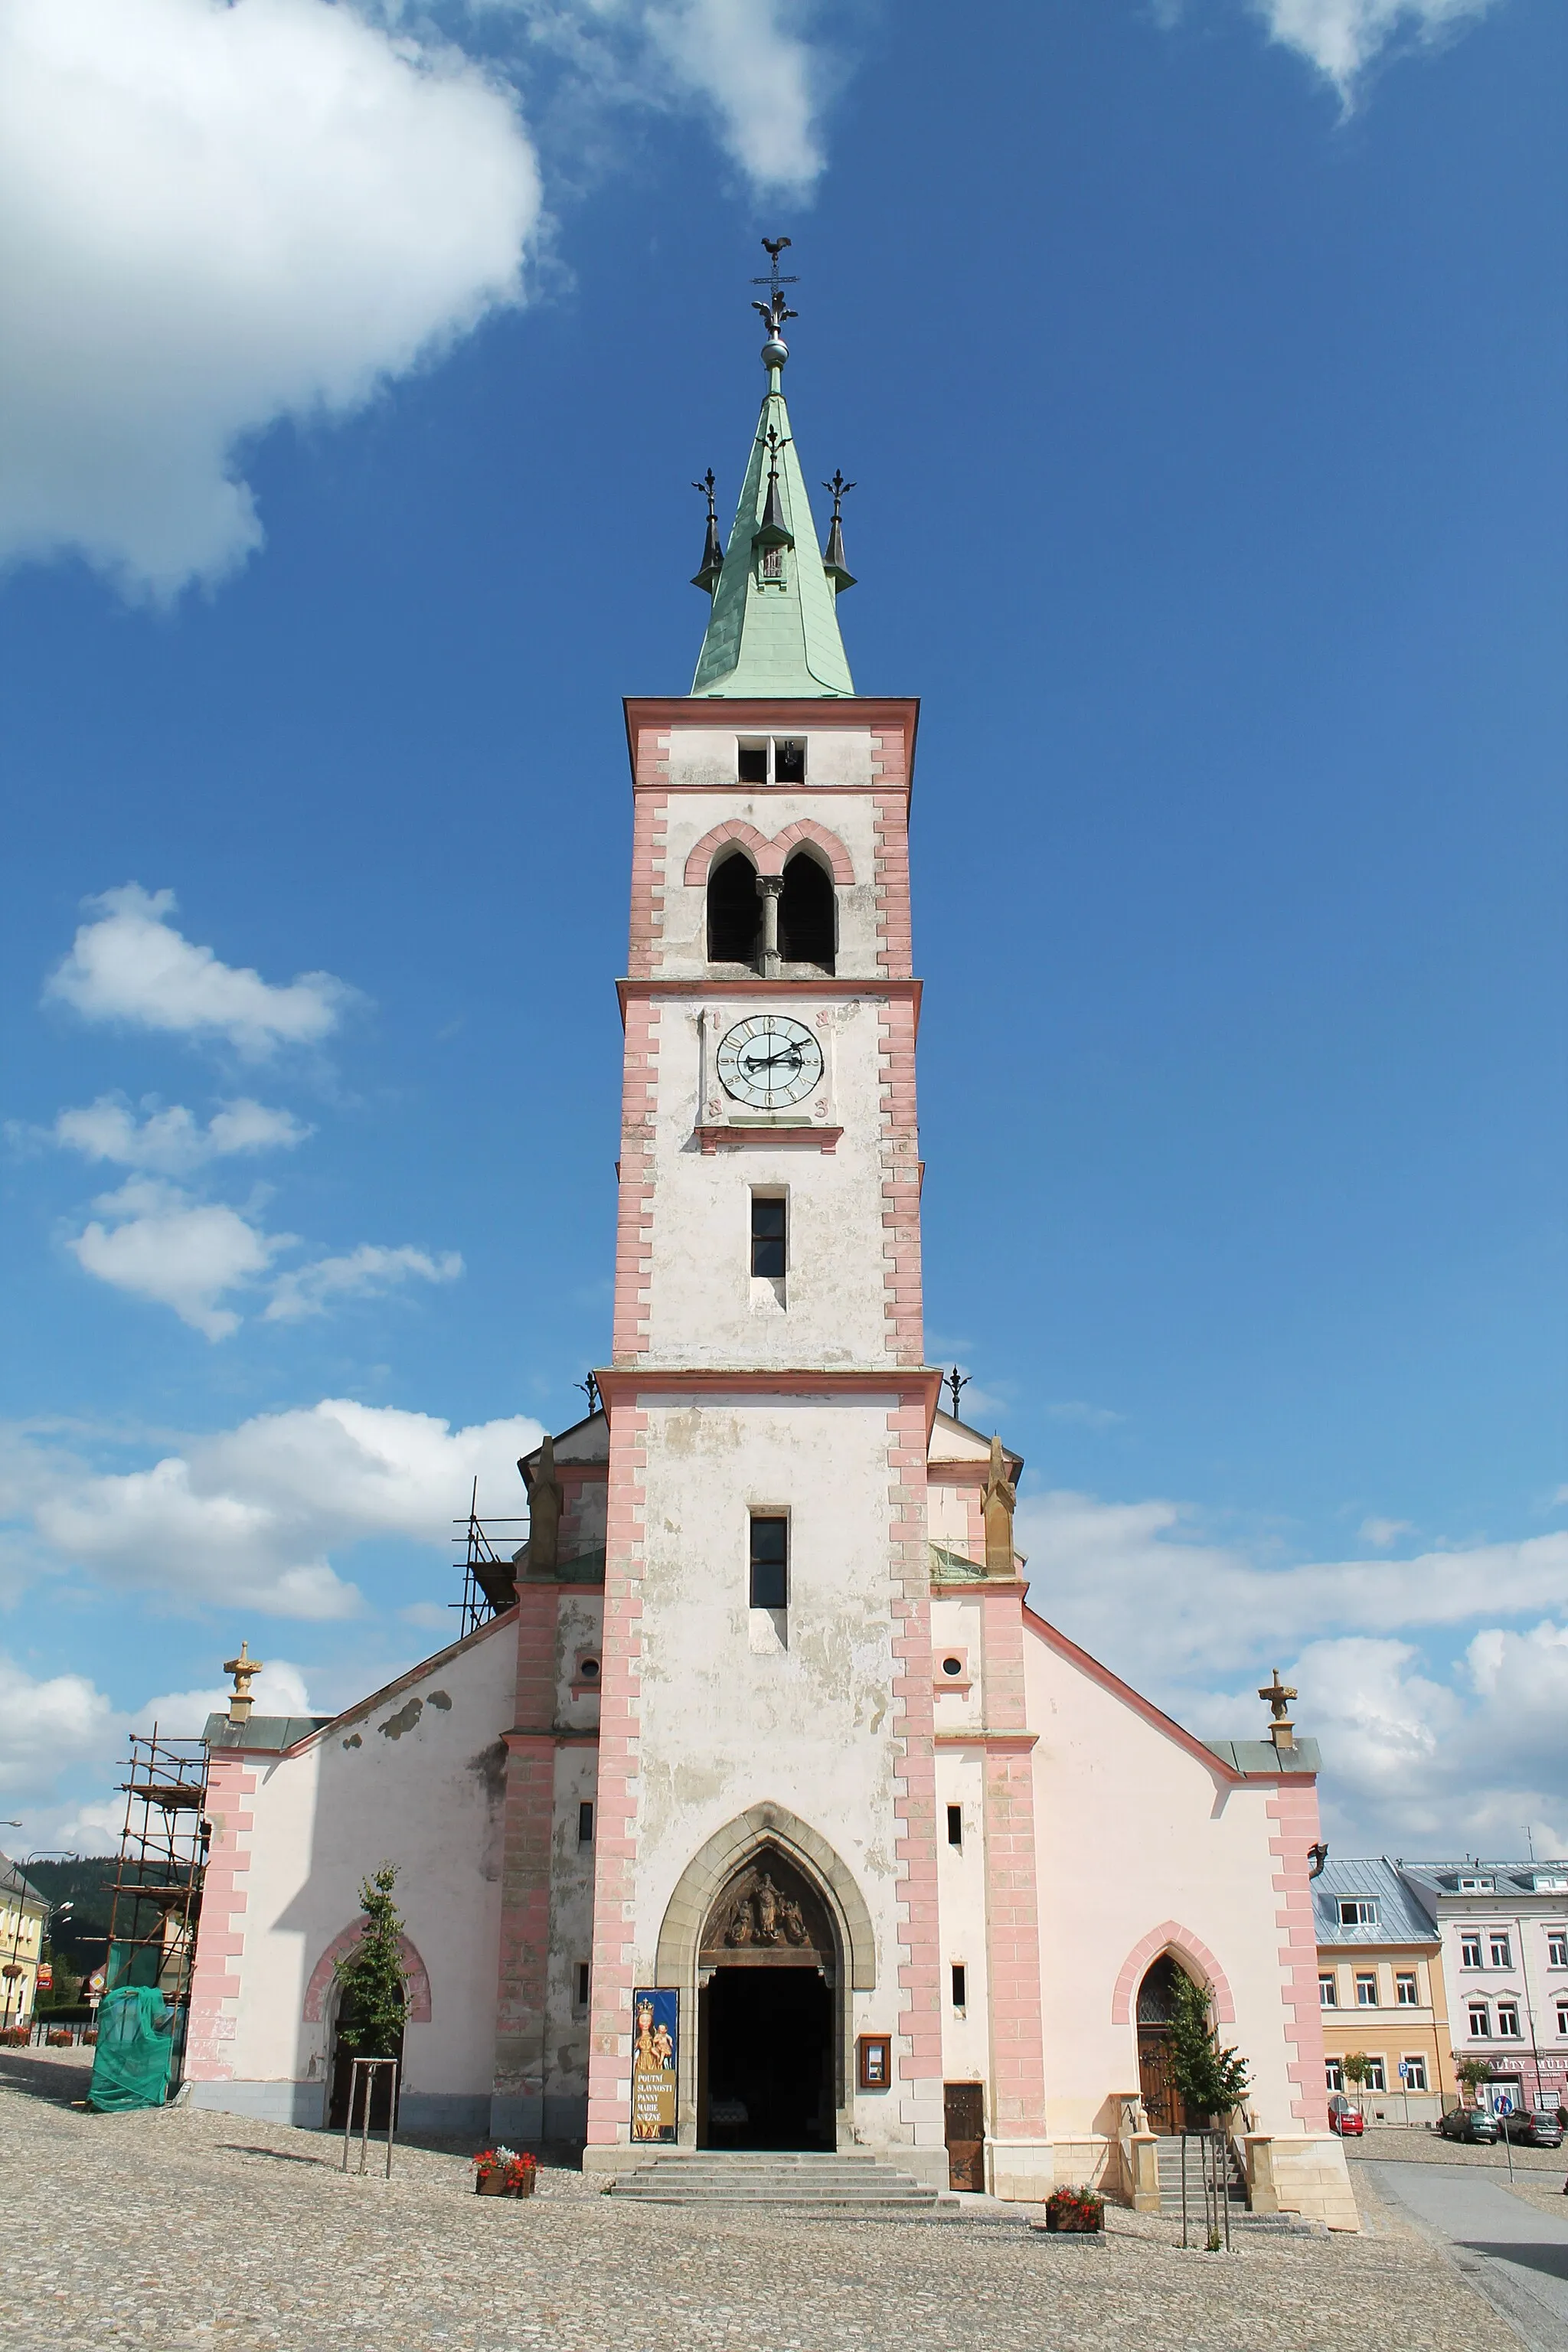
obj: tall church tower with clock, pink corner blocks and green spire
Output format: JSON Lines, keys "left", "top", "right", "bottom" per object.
{"left": 576, "top": 252, "right": 947, "bottom": 2180}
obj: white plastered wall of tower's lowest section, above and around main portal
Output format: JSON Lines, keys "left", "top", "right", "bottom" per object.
{"left": 635, "top": 1387, "right": 912, "bottom": 2145}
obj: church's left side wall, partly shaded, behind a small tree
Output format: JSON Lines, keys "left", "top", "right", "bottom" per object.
{"left": 195, "top": 1621, "right": 514, "bottom": 2122}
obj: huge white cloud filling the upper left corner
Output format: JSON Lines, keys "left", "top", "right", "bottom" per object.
{"left": 0, "top": 0, "right": 541, "bottom": 597}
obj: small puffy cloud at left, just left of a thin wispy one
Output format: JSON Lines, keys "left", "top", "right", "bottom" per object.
{"left": 68, "top": 1176, "right": 294, "bottom": 1341}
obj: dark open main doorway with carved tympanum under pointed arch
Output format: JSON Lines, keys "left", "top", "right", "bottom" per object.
{"left": 696, "top": 1847, "right": 841, "bottom": 2150}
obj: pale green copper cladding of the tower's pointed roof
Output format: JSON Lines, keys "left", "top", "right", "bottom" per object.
{"left": 691, "top": 367, "right": 856, "bottom": 696}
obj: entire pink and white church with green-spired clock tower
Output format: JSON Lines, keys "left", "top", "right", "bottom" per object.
{"left": 186, "top": 275, "right": 1357, "bottom": 2227}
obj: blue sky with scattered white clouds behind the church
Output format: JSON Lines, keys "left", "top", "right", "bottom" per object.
{"left": 0, "top": 0, "right": 1568, "bottom": 1854}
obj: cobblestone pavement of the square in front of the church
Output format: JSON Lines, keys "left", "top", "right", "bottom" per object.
{"left": 0, "top": 2053, "right": 1502, "bottom": 2352}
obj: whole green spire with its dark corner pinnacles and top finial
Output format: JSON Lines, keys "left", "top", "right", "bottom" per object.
{"left": 691, "top": 237, "right": 856, "bottom": 696}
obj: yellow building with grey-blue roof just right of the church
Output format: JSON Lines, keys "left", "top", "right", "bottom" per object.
{"left": 1312, "top": 1860, "right": 1458, "bottom": 2124}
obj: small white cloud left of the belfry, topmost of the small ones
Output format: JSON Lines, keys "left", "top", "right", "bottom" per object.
{"left": 44, "top": 882, "right": 355, "bottom": 1063}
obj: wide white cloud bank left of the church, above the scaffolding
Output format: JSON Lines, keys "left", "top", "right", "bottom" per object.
{"left": 7, "top": 1397, "right": 543, "bottom": 1619}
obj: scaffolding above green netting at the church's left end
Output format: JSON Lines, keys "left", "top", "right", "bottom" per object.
{"left": 108, "top": 1724, "right": 211, "bottom": 2060}
